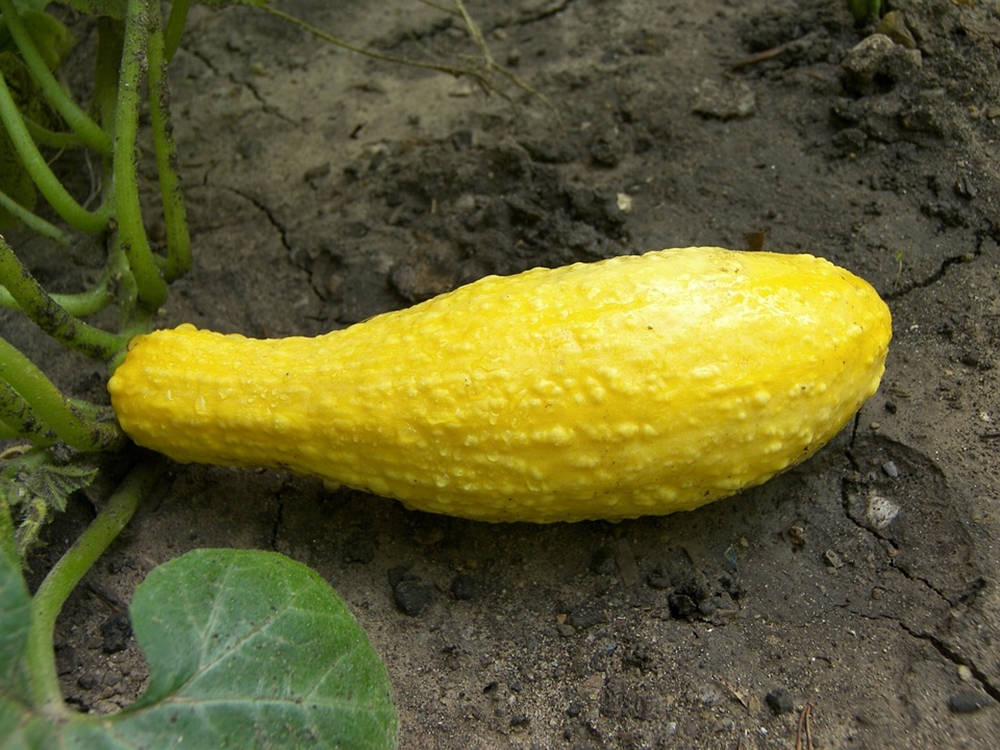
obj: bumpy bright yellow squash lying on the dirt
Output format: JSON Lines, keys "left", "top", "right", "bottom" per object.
{"left": 109, "top": 248, "right": 891, "bottom": 522}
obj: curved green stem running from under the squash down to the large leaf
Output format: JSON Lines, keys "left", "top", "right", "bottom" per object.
{"left": 25, "top": 459, "right": 163, "bottom": 717}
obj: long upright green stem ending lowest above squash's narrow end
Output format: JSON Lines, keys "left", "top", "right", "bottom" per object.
{"left": 113, "top": 0, "right": 167, "bottom": 309}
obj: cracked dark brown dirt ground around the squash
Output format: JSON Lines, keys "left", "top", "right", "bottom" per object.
{"left": 5, "top": 0, "right": 1000, "bottom": 750}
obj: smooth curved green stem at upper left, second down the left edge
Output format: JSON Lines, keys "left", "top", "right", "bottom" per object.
{"left": 0, "top": 71, "right": 111, "bottom": 233}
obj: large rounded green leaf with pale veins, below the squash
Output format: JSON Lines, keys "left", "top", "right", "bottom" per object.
{"left": 111, "top": 550, "right": 396, "bottom": 750}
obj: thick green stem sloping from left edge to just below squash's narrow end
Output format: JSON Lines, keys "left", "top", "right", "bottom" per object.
{"left": 0, "top": 337, "right": 124, "bottom": 451}
